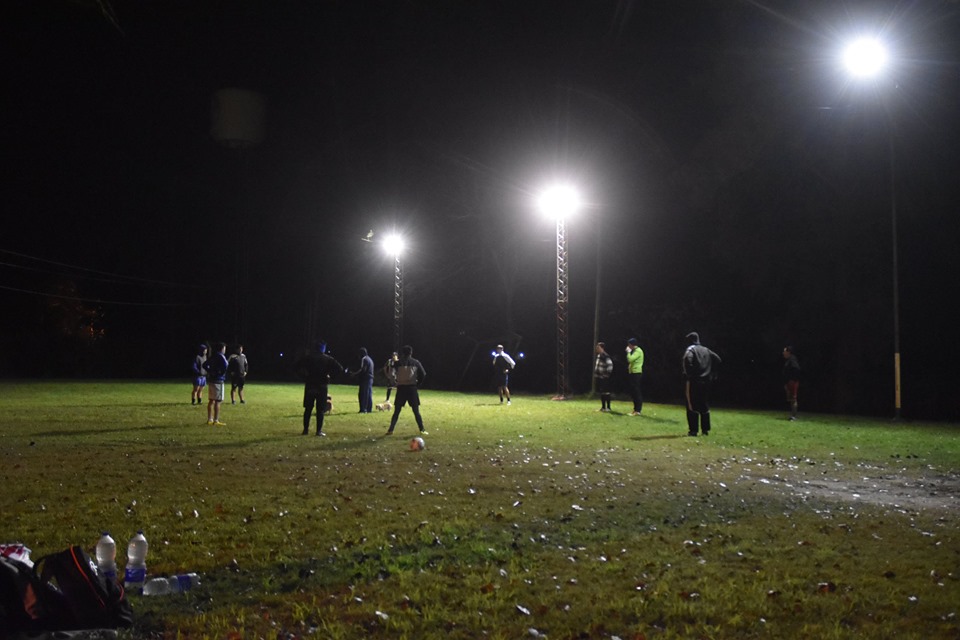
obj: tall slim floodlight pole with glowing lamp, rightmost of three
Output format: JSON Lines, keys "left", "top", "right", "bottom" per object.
{"left": 843, "top": 38, "right": 900, "bottom": 420}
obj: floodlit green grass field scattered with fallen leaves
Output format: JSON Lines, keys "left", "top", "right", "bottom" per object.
{"left": 0, "top": 382, "right": 960, "bottom": 639}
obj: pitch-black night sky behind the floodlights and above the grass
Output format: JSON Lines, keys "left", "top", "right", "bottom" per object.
{"left": 0, "top": 0, "right": 960, "bottom": 419}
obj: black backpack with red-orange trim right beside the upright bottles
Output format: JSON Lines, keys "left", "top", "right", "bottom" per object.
{"left": 34, "top": 545, "right": 133, "bottom": 629}
